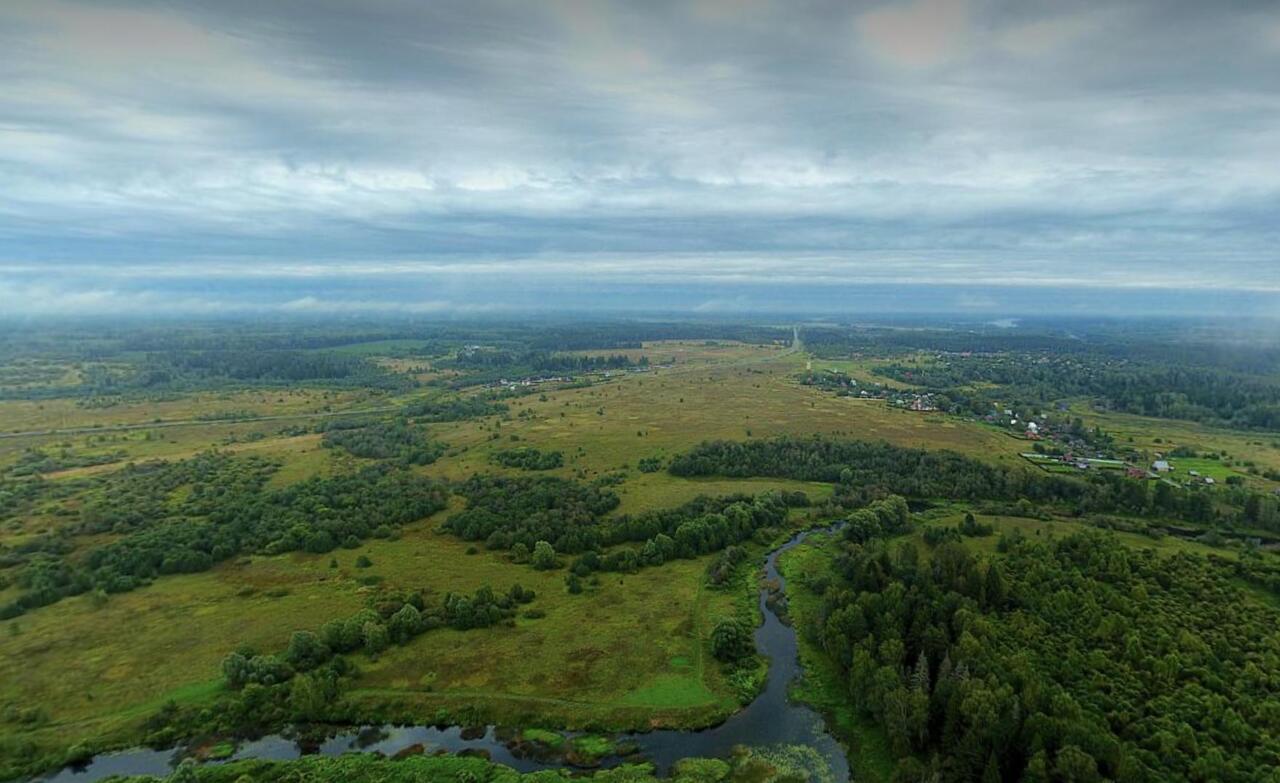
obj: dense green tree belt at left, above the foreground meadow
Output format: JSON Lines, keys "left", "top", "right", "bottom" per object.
{"left": 0, "top": 454, "right": 448, "bottom": 617}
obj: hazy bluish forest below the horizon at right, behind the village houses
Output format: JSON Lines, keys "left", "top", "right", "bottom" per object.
{"left": 805, "top": 328, "right": 1280, "bottom": 431}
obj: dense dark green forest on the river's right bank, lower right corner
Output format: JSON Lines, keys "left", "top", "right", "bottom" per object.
{"left": 801, "top": 534, "right": 1280, "bottom": 782}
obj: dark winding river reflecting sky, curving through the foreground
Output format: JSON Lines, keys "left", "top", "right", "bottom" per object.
{"left": 37, "top": 528, "right": 849, "bottom": 783}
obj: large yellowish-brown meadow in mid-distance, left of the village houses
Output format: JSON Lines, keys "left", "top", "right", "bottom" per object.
{"left": 419, "top": 349, "right": 1019, "bottom": 481}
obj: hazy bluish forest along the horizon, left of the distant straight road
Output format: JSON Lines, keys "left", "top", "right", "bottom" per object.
{"left": 0, "top": 321, "right": 791, "bottom": 399}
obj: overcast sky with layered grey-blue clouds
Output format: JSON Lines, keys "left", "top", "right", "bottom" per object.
{"left": 0, "top": 0, "right": 1280, "bottom": 317}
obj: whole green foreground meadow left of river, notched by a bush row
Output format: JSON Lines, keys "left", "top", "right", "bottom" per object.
{"left": 0, "top": 496, "right": 768, "bottom": 746}
